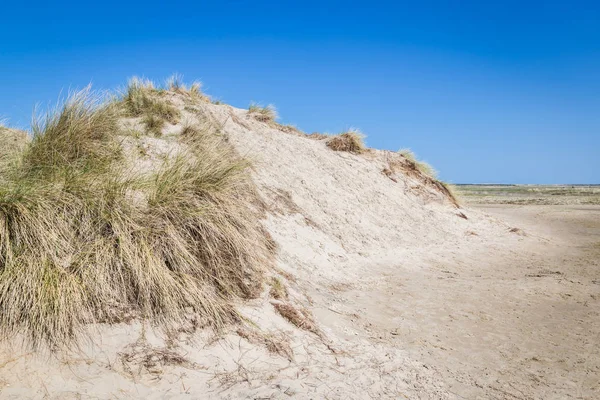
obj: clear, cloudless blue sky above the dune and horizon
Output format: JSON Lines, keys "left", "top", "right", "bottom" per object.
{"left": 0, "top": 0, "right": 600, "bottom": 183}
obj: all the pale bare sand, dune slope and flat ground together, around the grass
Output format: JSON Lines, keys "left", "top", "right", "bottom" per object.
{"left": 0, "top": 98, "right": 600, "bottom": 399}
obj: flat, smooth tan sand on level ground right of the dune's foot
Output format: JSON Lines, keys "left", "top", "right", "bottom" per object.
{"left": 314, "top": 206, "right": 600, "bottom": 399}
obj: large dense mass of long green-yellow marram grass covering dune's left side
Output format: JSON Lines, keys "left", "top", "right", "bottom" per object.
{"left": 0, "top": 85, "right": 272, "bottom": 346}
